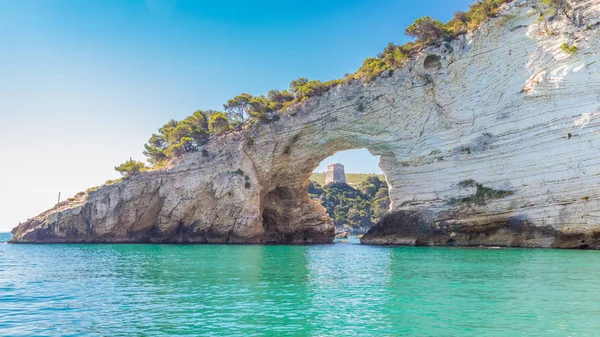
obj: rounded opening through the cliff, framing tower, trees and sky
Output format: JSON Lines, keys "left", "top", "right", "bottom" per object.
{"left": 307, "top": 149, "right": 390, "bottom": 243}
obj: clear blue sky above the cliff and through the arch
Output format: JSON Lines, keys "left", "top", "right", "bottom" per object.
{"left": 0, "top": 0, "right": 472, "bottom": 232}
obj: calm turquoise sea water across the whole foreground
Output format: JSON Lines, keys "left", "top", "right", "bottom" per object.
{"left": 0, "top": 234, "right": 600, "bottom": 336}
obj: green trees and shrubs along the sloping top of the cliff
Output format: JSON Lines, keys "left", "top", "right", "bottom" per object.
{"left": 120, "top": 0, "right": 574, "bottom": 176}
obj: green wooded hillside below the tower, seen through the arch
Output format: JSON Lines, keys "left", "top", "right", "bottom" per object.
{"left": 308, "top": 175, "right": 390, "bottom": 233}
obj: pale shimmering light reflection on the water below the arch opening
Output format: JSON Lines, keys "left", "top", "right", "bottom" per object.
{"left": 308, "top": 244, "right": 391, "bottom": 336}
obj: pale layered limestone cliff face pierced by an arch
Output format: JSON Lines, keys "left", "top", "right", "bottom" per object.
{"left": 13, "top": 0, "right": 600, "bottom": 248}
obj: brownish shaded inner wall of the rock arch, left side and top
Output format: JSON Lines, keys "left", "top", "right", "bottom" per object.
{"left": 260, "top": 130, "right": 396, "bottom": 243}
